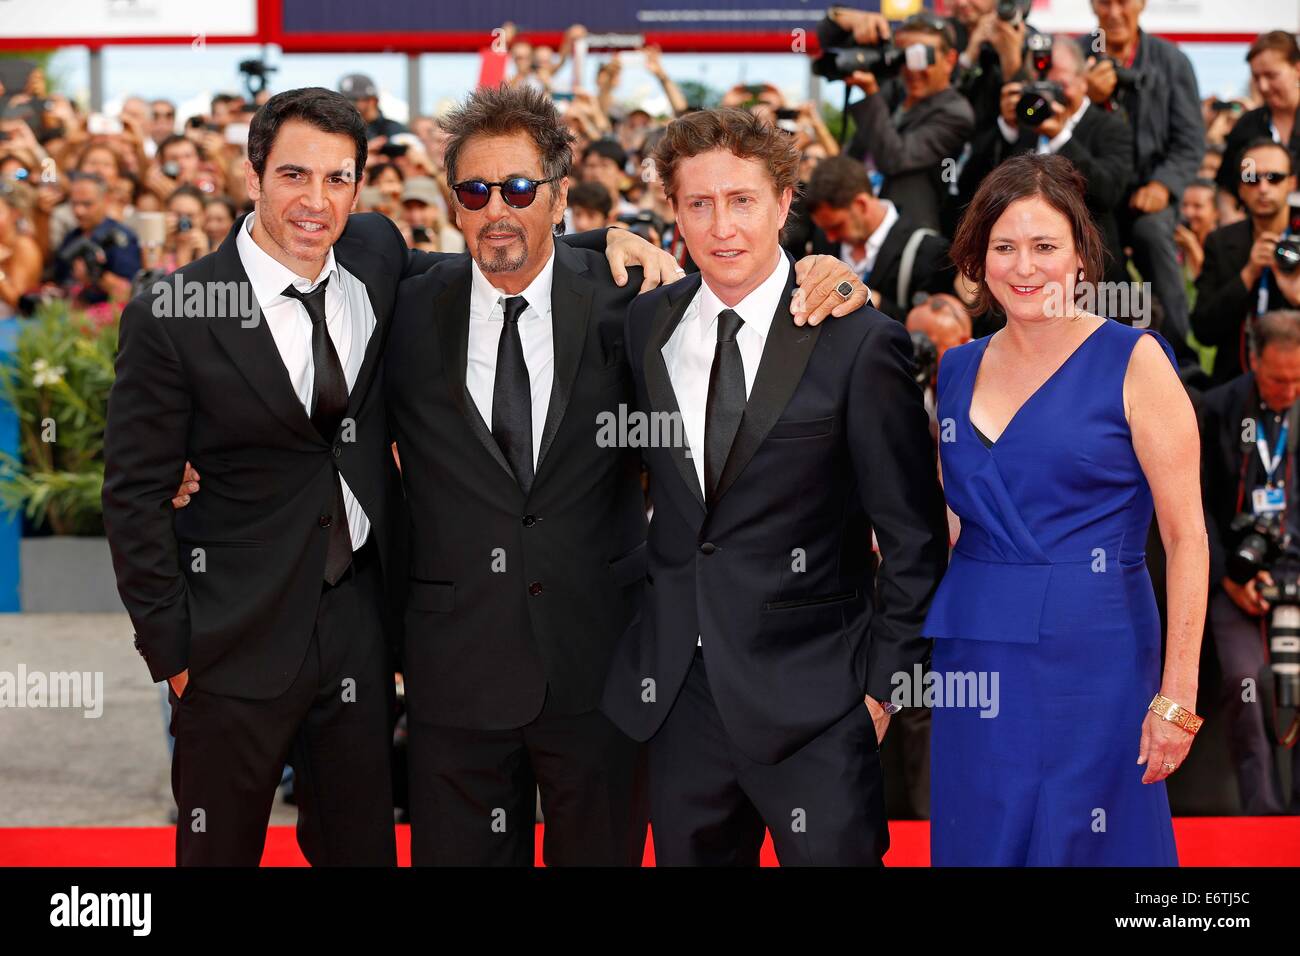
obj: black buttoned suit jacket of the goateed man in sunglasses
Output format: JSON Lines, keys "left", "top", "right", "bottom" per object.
{"left": 386, "top": 243, "right": 646, "bottom": 730}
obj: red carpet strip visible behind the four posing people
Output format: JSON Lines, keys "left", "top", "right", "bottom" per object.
{"left": 0, "top": 817, "right": 1300, "bottom": 866}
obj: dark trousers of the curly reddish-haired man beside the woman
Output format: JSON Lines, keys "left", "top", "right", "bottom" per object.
{"left": 650, "top": 649, "right": 889, "bottom": 866}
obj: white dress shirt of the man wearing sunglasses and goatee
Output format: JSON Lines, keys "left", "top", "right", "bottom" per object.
{"left": 465, "top": 247, "right": 555, "bottom": 471}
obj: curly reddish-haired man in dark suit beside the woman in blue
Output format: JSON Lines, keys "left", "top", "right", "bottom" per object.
{"left": 603, "top": 109, "right": 948, "bottom": 865}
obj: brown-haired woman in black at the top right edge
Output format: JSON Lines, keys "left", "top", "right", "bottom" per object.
{"left": 1218, "top": 30, "right": 1300, "bottom": 204}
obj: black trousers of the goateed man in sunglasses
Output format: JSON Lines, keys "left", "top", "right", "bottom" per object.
{"left": 407, "top": 698, "right": 647, "bottom": 866}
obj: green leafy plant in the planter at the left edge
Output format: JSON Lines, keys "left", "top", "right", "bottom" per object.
{"left": 0, "top": 300, "right": 117, "bottom": 535}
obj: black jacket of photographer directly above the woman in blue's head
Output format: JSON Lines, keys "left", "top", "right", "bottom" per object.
{"left": 961, "top": 103, "right": 1136, "bottom": 281}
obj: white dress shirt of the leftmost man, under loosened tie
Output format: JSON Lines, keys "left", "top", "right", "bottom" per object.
{"left": 235, "top": 216, "right": 376, "bottom": 550}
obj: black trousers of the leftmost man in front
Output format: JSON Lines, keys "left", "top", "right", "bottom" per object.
{"left": 169, "top": 535, "right": 397, "bottom": 866}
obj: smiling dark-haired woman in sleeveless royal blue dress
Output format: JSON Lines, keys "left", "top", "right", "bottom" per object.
{"left": 924, "top": 155, "right": 1209, "bottom": 866}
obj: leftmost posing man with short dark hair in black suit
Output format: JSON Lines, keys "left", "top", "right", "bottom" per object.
{"left": 104, "top": 88, "right": 681, "bottom": 865}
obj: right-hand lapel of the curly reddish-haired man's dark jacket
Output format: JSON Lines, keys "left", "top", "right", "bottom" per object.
{"left": 714, "top": 257, "right": 821, "bottom": 507}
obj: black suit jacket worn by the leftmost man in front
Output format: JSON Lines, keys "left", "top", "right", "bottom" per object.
{"left": 103, "top": 213, "right": 410, "bottom": 698}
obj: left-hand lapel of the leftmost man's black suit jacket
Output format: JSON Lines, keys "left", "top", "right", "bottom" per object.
{"left": 209, "top": 219, "right": 325, "bottom": 444}
